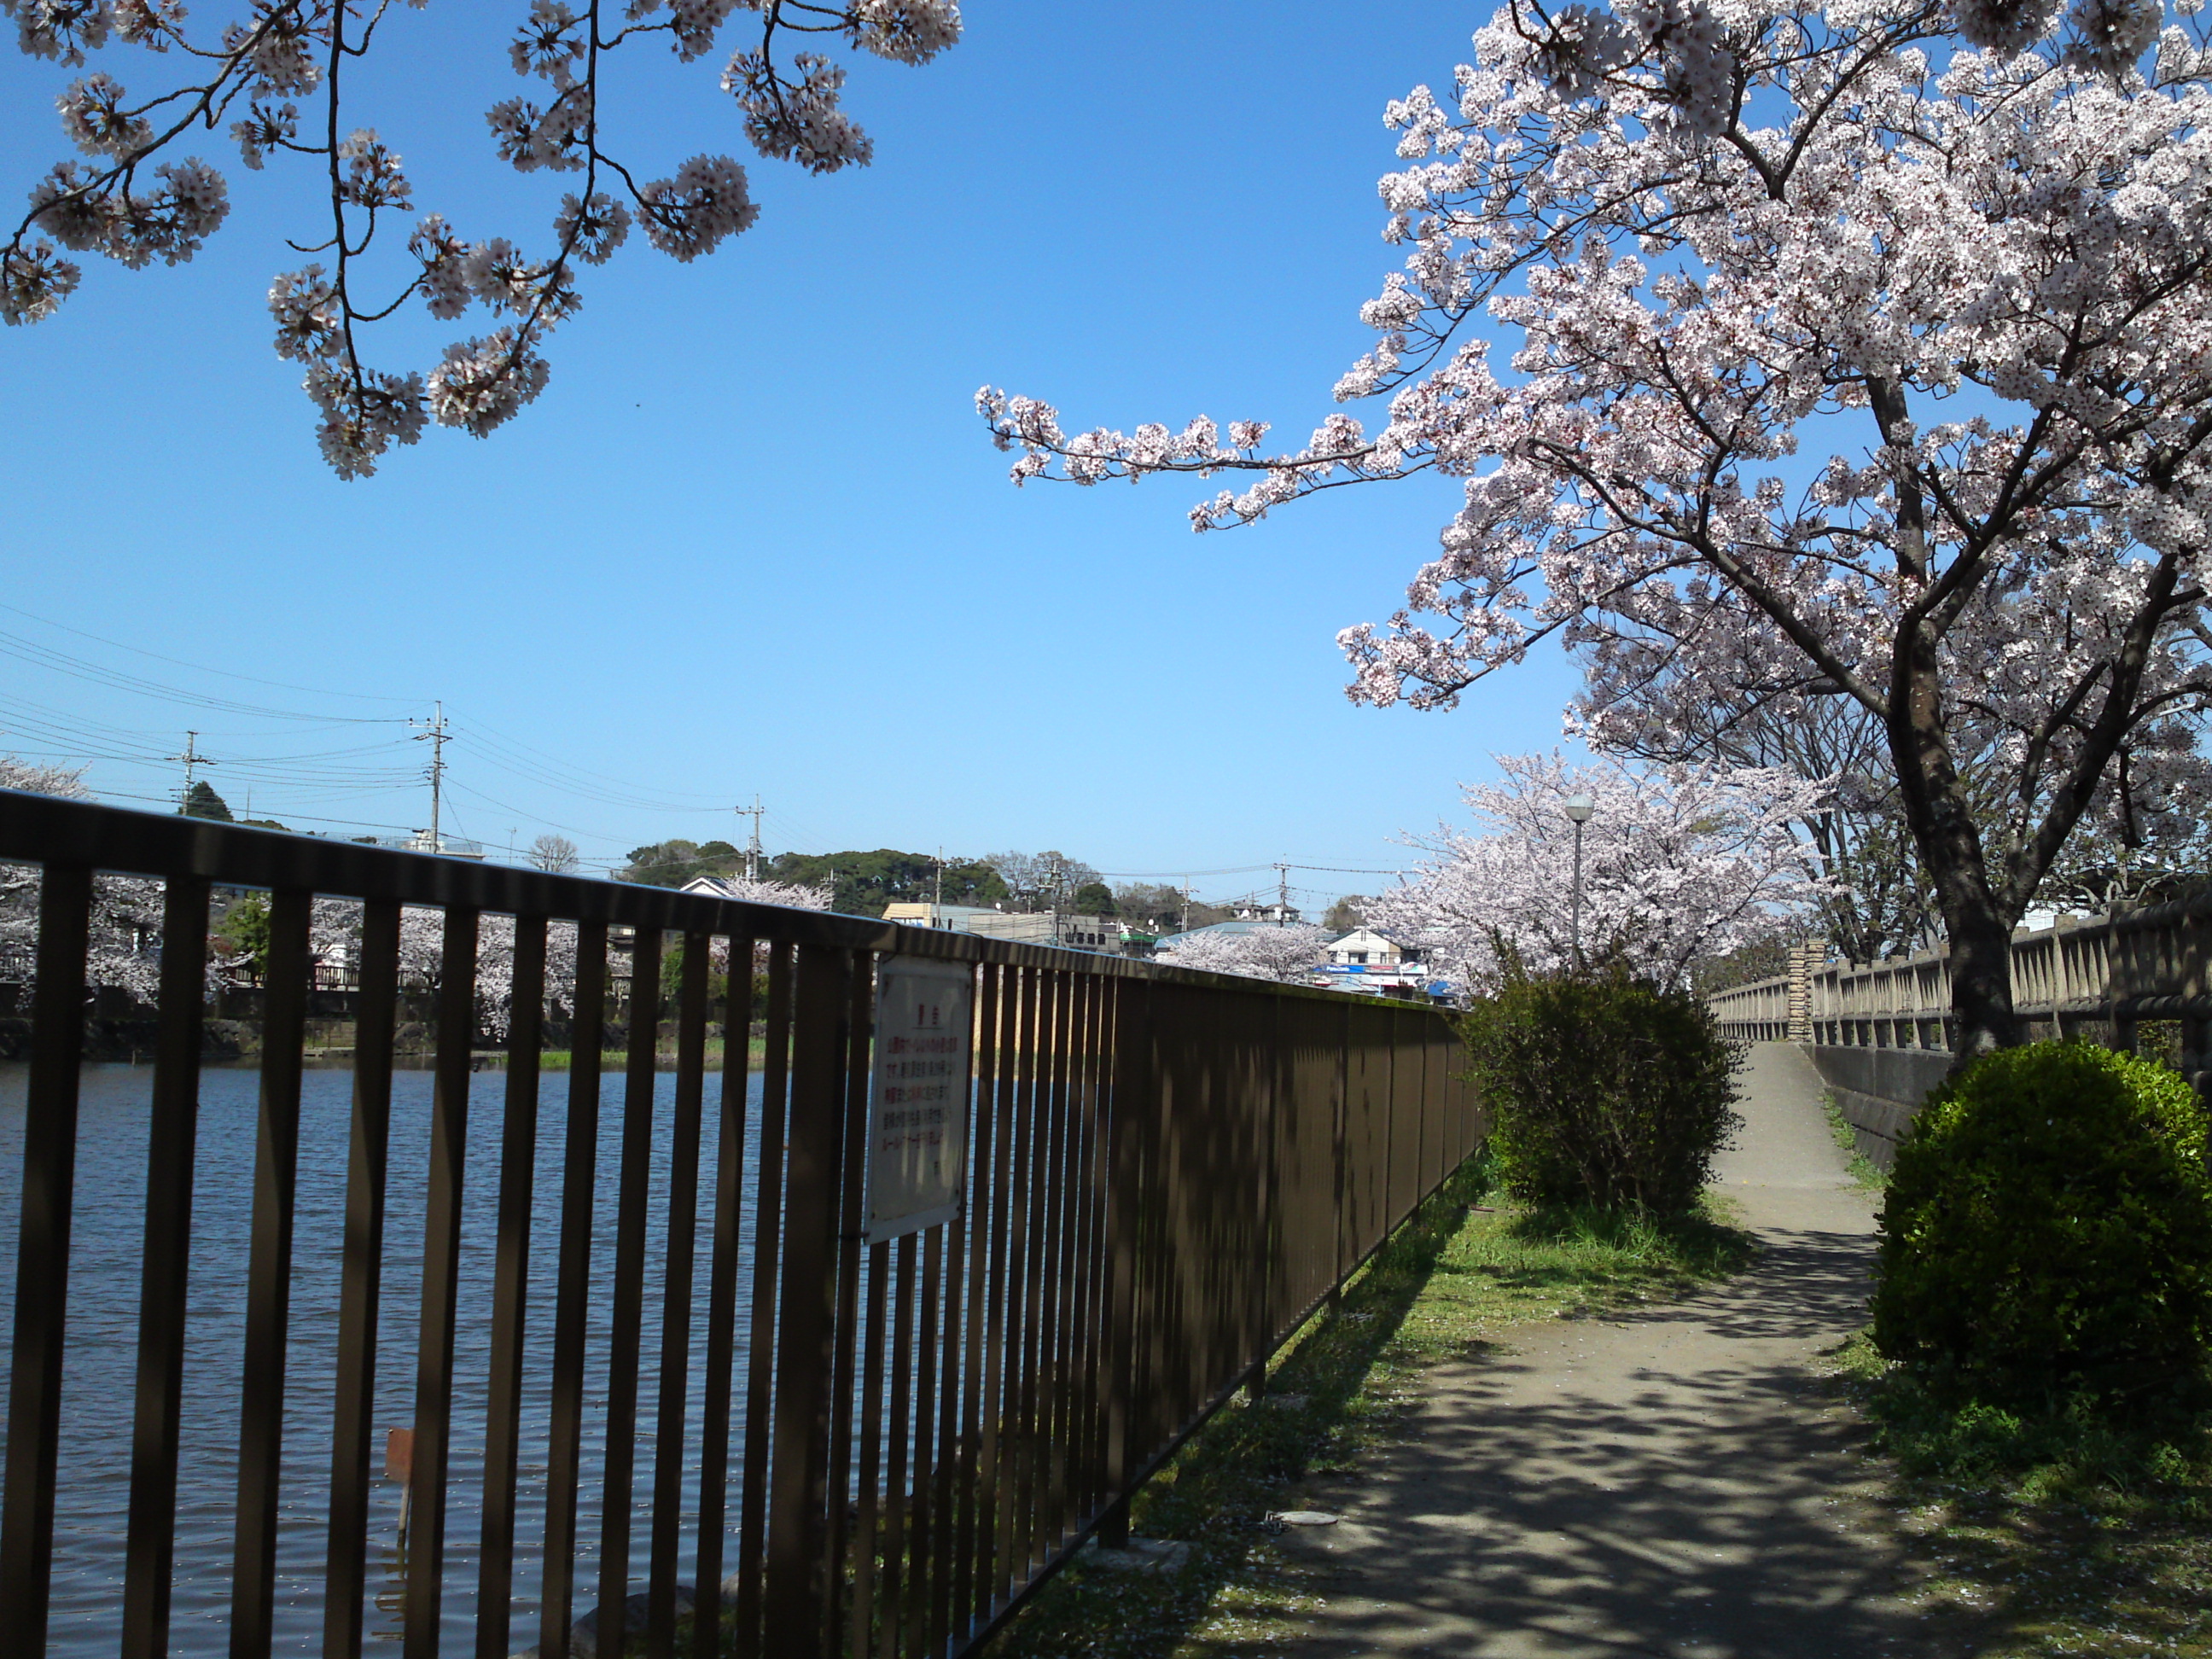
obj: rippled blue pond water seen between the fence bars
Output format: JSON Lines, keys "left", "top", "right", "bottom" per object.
{"left": 0, "top": 1066, "right": 761, "bottom": 1659}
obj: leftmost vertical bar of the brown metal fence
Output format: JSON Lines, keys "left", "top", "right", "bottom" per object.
{"left": 0, "top": 864, "right": 93, "bottom": 1655}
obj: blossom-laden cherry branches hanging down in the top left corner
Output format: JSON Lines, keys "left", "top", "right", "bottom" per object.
{"left": 0, "top": 0, "right": 960, "bottom": 478}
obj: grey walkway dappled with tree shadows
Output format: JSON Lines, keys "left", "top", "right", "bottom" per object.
{"left": 1278, "top": 1044, "right": 1970, "bottom": 1659}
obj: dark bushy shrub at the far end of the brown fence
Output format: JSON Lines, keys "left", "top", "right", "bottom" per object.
{"left": 1462, "top": 963, "right": 1741, "bottom": 1214}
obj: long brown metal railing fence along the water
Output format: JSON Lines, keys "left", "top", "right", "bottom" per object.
{"left": 0, "top": 795, "right": 1484, "bottom": 1659}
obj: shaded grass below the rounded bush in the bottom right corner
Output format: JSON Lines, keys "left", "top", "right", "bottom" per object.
{"left": 1831, "top": 1334, "right": 2212, "bottom": 1659}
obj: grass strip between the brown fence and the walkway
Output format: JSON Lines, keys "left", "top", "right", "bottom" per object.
{"left": 989, "top": 1163, "right": 1752, "bottom": 1659}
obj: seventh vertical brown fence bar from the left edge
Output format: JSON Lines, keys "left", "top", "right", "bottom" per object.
{"left": 538, "top": 923, "right": 606, "bottom": 1656}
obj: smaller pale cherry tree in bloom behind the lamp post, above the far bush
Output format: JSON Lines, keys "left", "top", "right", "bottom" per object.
{"left": 1367, "top": 754, "right": 1834, "bottom": 993}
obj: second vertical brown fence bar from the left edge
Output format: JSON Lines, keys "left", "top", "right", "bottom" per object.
{"left": 122, "top": 876, "right": 208, "bottom": 1659}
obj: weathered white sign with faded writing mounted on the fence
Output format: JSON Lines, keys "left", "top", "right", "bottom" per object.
{"left": 867, "top": 956, "right": 975, "bottom": 1243}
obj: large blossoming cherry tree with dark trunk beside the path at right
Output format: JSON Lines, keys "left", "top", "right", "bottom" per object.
{"left": 980, "top": 0, "right": 2212, "bottom": 1053}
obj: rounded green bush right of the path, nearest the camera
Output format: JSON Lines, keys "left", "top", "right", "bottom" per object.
{"left": 1873, "top": 1042, "right": 2212, "bottom": 1409}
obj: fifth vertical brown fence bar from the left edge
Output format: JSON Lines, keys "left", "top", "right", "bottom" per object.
{"left": 403, "top": 907, "right": 478, "bottom": 1659}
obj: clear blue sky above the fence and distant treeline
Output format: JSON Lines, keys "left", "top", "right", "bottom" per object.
{"left": 0, "top": 0, "right": 1570, "bottom": 911}
